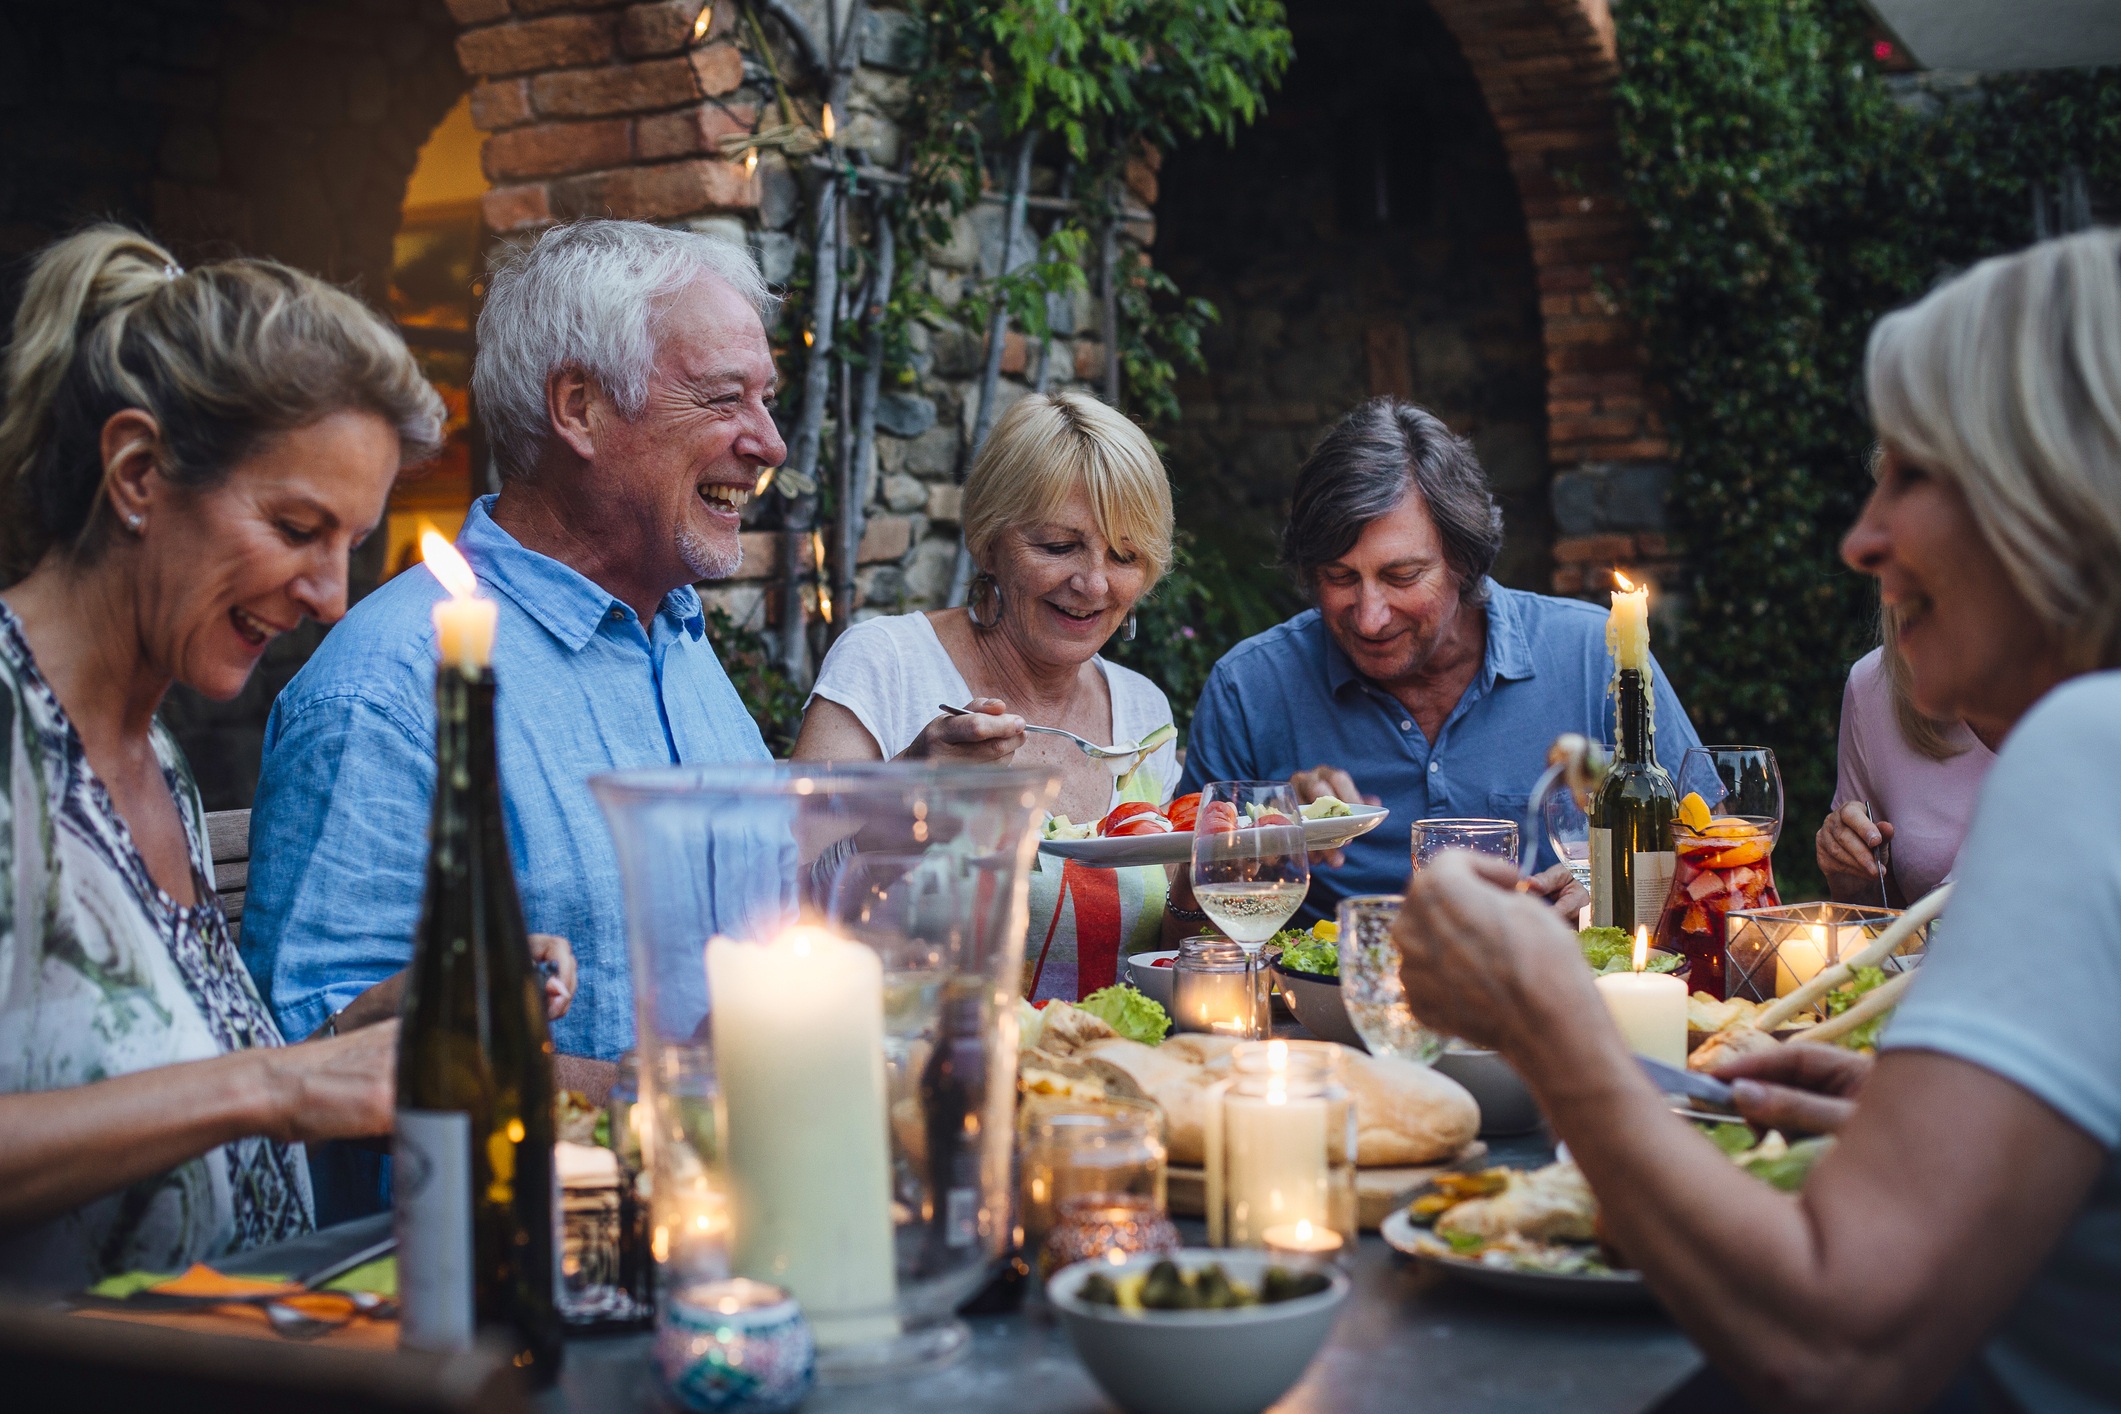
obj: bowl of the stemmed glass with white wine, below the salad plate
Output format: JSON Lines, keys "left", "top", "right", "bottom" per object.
{"left": 1192, "top": 780, "right": 1311, "bottom": 952}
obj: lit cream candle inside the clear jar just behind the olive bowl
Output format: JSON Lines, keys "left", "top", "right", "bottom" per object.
{"left": 1209, "top": 1041, "right": 1328, "bottom": 1247}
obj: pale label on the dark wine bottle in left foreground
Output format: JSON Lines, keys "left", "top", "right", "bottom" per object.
{"left": 390, "top": 1109, "right": 475, "bottom": 1350}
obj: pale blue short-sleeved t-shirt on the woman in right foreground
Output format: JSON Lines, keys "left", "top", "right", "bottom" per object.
{"left": 1881, "top": 672, "right": 2121, "bottom": 1414}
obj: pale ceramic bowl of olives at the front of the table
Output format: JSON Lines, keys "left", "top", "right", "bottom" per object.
{"left": 1046, "top": 1247, "right": 1349, "bottom": 1414}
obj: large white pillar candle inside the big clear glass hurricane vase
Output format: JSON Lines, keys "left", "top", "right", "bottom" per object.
{"left": 706, "top": 926, "right": 899, "bottom": 1348}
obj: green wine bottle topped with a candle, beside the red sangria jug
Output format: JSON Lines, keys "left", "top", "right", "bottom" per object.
{"left": 1591, "top": 668, "right": 1680, "bottom": 933}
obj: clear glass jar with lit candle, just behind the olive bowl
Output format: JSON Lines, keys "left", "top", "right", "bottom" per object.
{"left": 1203, "top": 1041, "right": 1357, "bottom": 1249}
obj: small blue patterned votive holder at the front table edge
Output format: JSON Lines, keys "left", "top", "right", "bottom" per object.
{"left": 655, "top": 1276, "right": 817, "bottom": 1414}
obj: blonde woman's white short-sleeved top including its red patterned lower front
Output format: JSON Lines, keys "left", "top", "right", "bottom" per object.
{"left": 804, "top": 613, "right": 1179, "bottom": 1001}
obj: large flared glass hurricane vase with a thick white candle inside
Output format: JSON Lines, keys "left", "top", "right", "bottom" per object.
{"left": 590, "top": 763, "right": 1056, "bottom": 1380}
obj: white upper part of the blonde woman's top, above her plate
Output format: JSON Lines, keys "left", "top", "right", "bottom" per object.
{"left": 804, "top": 613, "right": 1179, "bottom": 810}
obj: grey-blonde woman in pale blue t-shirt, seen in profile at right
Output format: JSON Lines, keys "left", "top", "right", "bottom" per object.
{"left": 1393, "top": 231, "right": 2121, "bottom": 1414}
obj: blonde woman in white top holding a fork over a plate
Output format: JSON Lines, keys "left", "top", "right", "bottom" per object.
{"left": 795, "top": 390, "right": 1179, "bottom": 1001}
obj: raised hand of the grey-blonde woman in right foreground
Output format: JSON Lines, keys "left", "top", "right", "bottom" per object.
{"left": 1391, "top": 850, "right": 1601, "bottom": 1051}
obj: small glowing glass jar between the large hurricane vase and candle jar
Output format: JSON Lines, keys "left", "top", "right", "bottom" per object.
{"left": 1018, "top": 1096, "right": 1164, "bottom": 1257}
